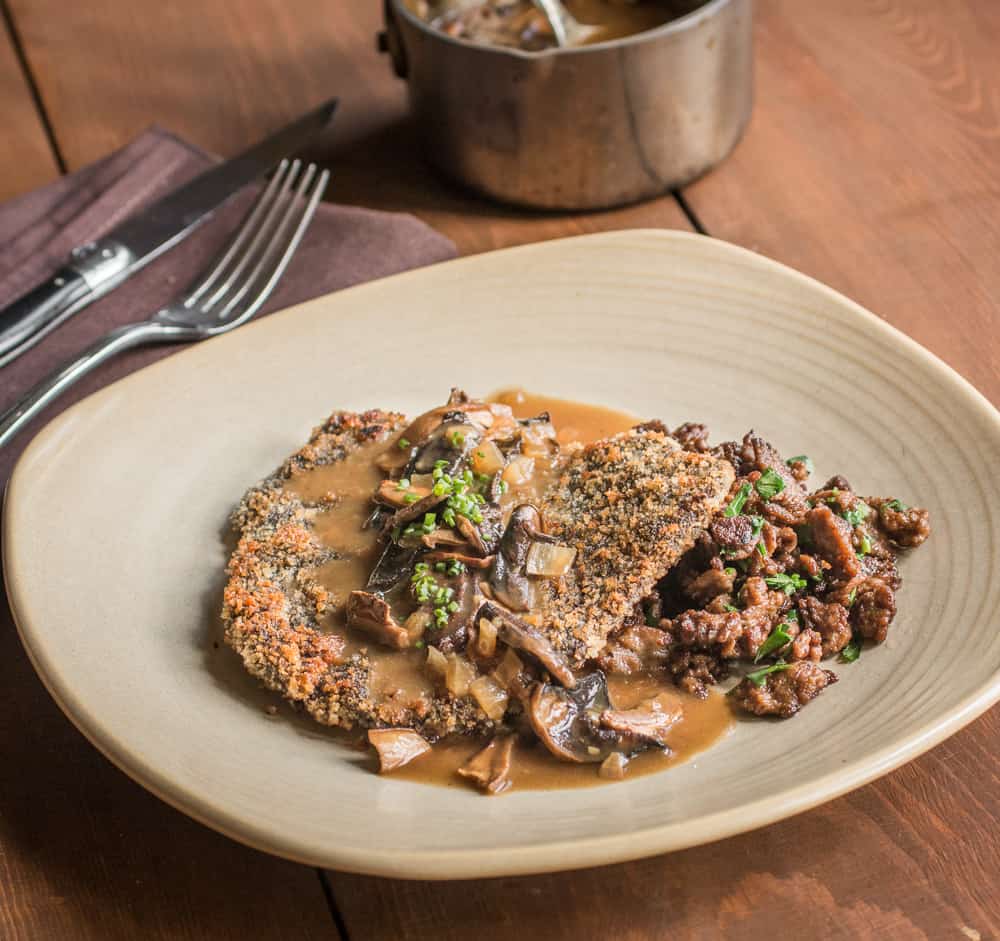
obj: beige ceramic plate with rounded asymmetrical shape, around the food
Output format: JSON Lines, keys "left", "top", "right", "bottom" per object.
{"left": 4, "top": 232, "right": 1000, "bottom": 878}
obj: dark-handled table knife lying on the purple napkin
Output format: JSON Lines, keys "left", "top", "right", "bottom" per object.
{"left": 0, "top": 98, "right": 337, "bottom": 367}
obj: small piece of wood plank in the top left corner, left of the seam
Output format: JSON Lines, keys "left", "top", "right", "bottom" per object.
{"left": 0, "top": 8, "right": 59, "bottom": 202}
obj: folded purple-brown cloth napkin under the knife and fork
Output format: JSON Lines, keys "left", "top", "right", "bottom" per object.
{"left": 0, "top": 128, "right": 455, "bottom": 483}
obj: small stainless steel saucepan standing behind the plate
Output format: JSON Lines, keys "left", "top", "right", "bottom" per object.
{"left": 380, "top": 0, "right": 753, "bottom": 209}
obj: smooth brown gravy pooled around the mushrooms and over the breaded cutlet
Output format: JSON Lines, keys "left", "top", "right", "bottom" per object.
{"left": 285, "top": 389, "right": 733, "bottom": 790}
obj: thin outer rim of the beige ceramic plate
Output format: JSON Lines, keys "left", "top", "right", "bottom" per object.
{"left": 2, "top": 228, "right": 1000, "bottom": 880}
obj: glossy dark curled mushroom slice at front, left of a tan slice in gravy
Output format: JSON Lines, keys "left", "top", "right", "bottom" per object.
{"left": 528, "top": 670, "right": 618, "bottom": 764}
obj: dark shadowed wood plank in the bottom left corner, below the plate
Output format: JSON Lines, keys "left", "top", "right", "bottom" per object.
{"left": 0, "top": 601, "right": 337, "bottom": 941}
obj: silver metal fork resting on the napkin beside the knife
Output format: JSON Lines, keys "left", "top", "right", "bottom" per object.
{"left": 0, "top": 160, "right": 330, "bottom": 448}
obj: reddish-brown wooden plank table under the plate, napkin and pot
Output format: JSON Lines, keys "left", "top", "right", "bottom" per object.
{"left": 0, "top": 0, "right": 1000, "bottom": 941}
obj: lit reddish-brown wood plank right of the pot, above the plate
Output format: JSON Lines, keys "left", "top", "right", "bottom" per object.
{"left": 686, "top": 0, "right": 1000, "bottom": 402}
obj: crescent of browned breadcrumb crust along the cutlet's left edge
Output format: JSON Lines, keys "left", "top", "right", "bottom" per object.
{"left": 222, "top": 410, "right": 493, "bottom": 740}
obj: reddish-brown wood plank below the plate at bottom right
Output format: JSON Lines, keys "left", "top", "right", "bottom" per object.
{"left": 328, "top": 710, "right": 1000, "bottom": 941}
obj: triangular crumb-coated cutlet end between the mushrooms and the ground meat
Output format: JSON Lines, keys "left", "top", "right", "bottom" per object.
{"left": 540, "top": 428, "right": 735, "bottom": 664}
